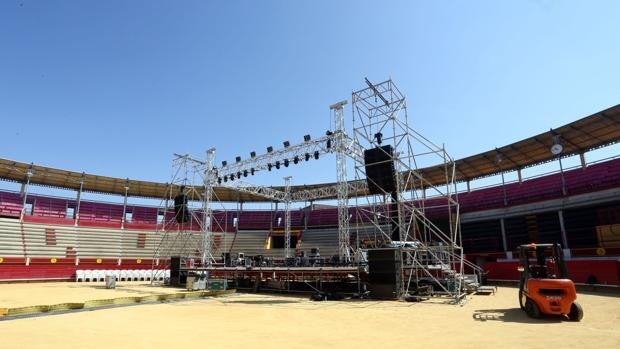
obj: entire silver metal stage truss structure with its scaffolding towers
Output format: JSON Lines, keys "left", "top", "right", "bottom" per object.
{"left": 153, "top": 79, "right": 480, "bottom": 301}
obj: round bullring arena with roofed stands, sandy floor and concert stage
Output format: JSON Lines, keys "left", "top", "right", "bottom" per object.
{"left": 0, "top": 79, "right": 620, "bottom": 348}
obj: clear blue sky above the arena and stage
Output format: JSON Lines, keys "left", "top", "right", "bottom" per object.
{"left": 0, "top": 0, "right": 620, "bottom": 189}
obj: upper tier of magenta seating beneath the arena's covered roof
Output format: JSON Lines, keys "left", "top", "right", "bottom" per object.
{"left": 0, "top": 159, "right": 620, "bottom": 232}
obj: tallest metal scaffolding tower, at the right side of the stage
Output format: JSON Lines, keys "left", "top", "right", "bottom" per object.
{"left": 352, "top": 79, "right": 478, "bottom": 299}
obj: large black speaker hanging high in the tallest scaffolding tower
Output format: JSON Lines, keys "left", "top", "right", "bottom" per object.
{"left": 364, "top": 145, "right": 396, "bottom": 194}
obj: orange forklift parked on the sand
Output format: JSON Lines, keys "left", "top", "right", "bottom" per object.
{"left": 518, "top": 243, "right": 583, "bottom": 321}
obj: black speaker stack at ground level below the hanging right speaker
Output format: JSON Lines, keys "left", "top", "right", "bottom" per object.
{"left": 368, "top": 248, "right": 401, "bottom": 299}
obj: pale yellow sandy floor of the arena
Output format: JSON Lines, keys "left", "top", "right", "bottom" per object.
{"left": 0, "top": 283, "right": 620, "bottom": 349}
